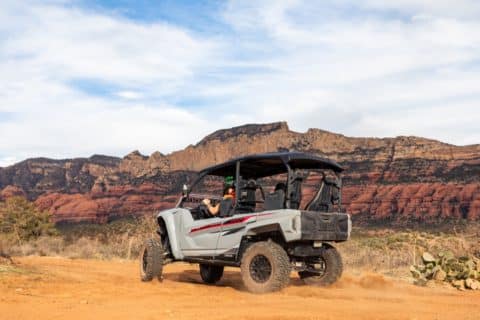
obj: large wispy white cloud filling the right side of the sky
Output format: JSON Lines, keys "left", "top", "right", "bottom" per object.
{"left": 217, "top": 1, "right": 480, "bottom": 144}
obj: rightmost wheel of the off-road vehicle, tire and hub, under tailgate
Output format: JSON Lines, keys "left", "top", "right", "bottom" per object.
{"left": 298, "top": 244, "right": 343, "bottom": 286}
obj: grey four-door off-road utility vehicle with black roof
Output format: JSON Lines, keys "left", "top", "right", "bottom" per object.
{"left": 140, "top": 152, "right": 351, "bottom": 293}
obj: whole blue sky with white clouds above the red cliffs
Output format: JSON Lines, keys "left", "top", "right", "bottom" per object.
{"left": 0, "top": 0, "right": 480, "bottom": 166}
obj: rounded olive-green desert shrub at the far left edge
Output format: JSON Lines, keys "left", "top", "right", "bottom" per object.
{"left": 0, "top": 197, "right": 57, "bottom": 243}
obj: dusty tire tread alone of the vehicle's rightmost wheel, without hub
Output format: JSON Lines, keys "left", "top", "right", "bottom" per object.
{"left": 298, "top": 244, "right": 343, "bottom": 286}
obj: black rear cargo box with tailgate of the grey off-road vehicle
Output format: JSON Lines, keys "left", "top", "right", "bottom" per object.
{"left": 301, "top": 211, "right": 352, "bottom": 241}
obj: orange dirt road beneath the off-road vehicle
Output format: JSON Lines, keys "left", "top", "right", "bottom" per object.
{"left": 0, "top": 257, "right": 480, "bottom": 320}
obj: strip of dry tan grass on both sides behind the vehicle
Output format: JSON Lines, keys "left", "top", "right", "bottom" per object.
{"left": 0, "top": 217, "right": 480, "bottom": 275}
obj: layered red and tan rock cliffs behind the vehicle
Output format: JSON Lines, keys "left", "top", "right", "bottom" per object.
{"left": 0, "top": 123, "right": 480, "bottom": 222}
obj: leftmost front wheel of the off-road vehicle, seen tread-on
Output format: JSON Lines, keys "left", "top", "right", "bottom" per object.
{"left": 140, "top": 239, "right": 163, "bottom": 281}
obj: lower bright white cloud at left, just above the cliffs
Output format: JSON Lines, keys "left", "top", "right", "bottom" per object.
{"left": 0, "top": 85, "right": 214, "bottom": 162}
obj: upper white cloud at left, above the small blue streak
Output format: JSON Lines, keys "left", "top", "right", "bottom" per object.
{"left": 0, "top": 4, "right": 213, "bottom": 91}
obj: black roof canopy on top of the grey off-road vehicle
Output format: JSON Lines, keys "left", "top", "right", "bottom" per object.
{"left": 200, "top": 152, "right": 343, "bottom": 179}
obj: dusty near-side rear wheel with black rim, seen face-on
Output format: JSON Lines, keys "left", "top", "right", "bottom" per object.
{"left": 240, "top": 241, "right": 291, "bottom": 293}
